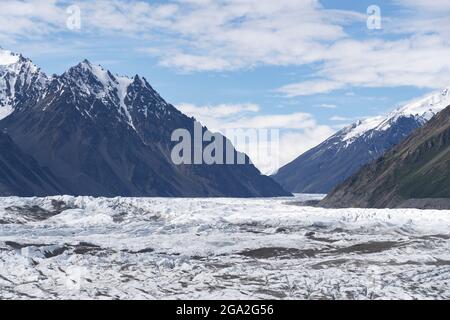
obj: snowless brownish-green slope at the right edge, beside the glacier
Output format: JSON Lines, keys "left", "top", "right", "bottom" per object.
{"left": 320, "top": 107, "right": 450, "bottom": 209}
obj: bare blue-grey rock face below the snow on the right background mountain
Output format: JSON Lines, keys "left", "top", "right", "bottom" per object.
{"left": 273, "top": 116, "right": 423, "bottom": 194}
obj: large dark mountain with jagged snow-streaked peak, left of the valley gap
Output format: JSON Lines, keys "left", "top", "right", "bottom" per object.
{"left": 0, "top": 50, "right": 289, "bottom": 197}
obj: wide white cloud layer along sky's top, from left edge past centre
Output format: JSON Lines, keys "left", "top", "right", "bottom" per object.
{"left": 0, "top": 0, "right": 363, "bottom": 71}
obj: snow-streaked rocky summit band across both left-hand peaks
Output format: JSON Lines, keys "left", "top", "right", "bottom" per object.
{"left": 0, "top": 48, "right": 170, "bottom": 131}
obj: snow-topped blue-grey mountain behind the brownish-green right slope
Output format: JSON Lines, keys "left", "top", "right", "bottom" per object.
{"left": 273, "top": 88, "right": 450, "bottom": 193}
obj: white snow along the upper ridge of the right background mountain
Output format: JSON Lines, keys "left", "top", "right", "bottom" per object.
{"left": 343, "top": 87, "right": 450, "bottom": 145}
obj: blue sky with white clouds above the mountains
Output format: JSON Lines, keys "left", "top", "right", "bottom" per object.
{"left": 0, "top": 0, "right": 450, "bottom": 172}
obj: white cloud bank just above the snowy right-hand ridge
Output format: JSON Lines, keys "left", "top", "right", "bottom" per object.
{"left": 278, "top": 35, "right": 450, "bottom": 97}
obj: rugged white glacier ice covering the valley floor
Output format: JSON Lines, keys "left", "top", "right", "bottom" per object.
{"left": 0, "top": 195, "right": 450, "bottom": 299}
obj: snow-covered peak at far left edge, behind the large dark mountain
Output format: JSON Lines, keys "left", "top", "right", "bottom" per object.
{"left": 0, "top": 48, "right": 49, "bottom": 120}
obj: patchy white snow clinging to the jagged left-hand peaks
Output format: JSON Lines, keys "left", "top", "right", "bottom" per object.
{"left": 0, "top": 48, "right": 162, "bottom": 131}
